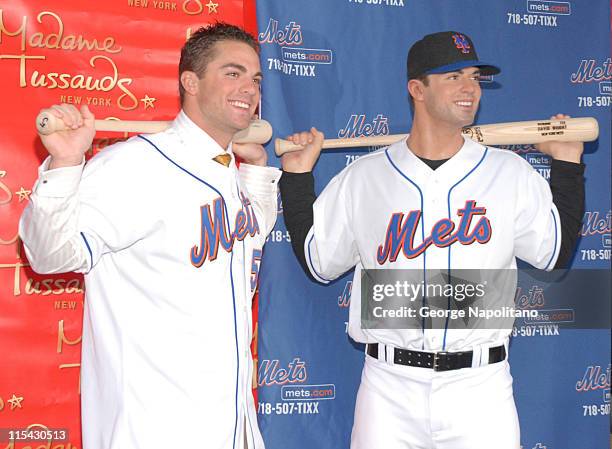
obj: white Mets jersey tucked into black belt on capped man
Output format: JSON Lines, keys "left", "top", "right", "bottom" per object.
{"left": 304, "top": 139, "right": 561, "bottom": 351}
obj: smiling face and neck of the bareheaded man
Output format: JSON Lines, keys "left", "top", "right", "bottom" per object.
{"left": 181, "top": 40, "right": 262, "bottom": 148}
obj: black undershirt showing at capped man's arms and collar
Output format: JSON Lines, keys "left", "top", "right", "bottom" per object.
{"left": 279, "top": 159, "right": 585, "bottom": 279}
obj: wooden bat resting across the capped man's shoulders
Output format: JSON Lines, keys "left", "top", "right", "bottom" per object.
{"left": 274, "top": 117, "right": 599, "bottom": 156}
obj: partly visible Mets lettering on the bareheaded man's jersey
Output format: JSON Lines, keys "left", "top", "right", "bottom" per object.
{"left": 189, "top": 194, "right": 259, "bottom": 267}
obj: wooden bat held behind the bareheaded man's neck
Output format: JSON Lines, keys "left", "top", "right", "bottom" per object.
{"left": 36, "top": 111, "right": 272, "bottom": 144}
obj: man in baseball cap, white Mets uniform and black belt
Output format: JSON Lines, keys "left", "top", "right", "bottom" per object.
{"left": 280, "top": 32, "right": 584, "bottom": 449}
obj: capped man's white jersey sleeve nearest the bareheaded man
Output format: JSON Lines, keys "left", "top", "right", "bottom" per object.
{"left": 304, "top": 170, "right": 359, "bottom": 283}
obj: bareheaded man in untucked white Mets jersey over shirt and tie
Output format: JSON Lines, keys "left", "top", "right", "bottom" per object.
{"left": 20, "top": 23, "right": 280, "bottom": 449}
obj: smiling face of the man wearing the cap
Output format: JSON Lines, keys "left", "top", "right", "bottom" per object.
{"left": 411, "top": 67, "right": 481, "bottom": 129}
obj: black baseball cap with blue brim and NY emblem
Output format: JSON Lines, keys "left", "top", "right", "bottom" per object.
{"left": 406, "top": 31, "right": 501, "bottom": 80}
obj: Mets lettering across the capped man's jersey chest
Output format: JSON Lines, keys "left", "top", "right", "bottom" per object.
{"left": 376, "top": 200, "right": 492, "bottom": 265}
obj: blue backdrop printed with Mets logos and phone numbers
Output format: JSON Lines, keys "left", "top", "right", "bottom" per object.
{"left": 252, "top": 0, "right": 612, "bottom": 449}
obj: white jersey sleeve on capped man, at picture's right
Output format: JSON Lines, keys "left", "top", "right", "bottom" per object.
{"left": 514, "top": 161, "right": 561, "bottom": 271}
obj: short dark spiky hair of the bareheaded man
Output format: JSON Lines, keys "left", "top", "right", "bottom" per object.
{"left": 179, "top": 22, "right": 259, "bottom": 105}
